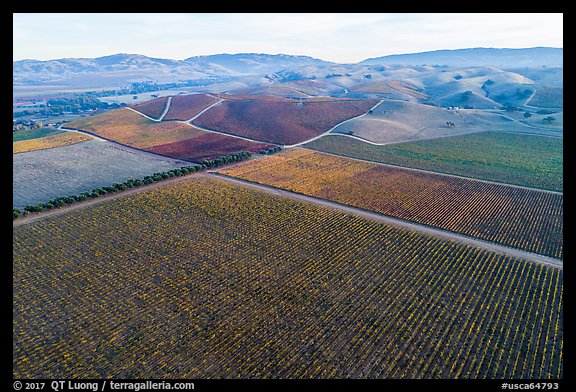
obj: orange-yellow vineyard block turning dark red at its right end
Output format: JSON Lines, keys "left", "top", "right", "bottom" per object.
{"left": 66, "top": 108, "right": 268, "bottom": 162}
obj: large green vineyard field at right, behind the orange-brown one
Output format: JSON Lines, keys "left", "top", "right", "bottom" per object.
{"left": 305, "top": 131, "right": 563, "bottom": 191}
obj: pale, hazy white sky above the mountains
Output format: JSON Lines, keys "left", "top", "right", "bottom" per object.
{"left": 13, "top": 13, "right": 563, "bottom": 63}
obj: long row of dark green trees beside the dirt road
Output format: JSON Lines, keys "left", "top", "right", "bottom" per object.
{"left": 13, "top": 151, "right": 252, "bottom": 220}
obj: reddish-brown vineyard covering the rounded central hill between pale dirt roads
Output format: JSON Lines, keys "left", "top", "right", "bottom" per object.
{"left": 193, "top": 97, "right": 378, "bottom": 145}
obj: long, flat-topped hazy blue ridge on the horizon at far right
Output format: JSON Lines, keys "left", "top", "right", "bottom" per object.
{"left": 360, "top": 47, "right": 564, "bottom": 67}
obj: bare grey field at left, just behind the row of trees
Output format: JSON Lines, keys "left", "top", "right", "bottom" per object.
{"left": 12, "top": 139, "right": 188, "bottom": 208}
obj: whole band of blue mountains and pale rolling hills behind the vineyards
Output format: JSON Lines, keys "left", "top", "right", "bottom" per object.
{"left": 13, "top": 47, "right": 563, "bottom": 109}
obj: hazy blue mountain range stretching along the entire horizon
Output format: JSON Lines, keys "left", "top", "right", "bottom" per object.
{"left": 12, "top": 47, "right": 563, "bottom": 85}
